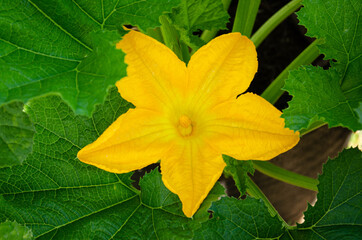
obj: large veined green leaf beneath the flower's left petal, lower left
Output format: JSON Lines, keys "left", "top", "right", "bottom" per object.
{"left": 0, "top": 87, "right": 221, "bottom": 239}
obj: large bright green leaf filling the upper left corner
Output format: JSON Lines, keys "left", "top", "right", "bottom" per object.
{"left": 0, "top": 0, "right": 179, "bottom": 115}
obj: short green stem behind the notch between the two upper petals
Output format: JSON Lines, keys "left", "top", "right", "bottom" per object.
{"left": 160, "top": 15, "right": 190, "bottom": 63}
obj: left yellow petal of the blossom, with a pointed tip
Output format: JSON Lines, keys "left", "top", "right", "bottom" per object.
{"left": 78, "top": 109, "right": 174, "bottom": 173}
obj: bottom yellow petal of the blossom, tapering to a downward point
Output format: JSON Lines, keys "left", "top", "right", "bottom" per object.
{"left": 161, "top": 139, "right": 225, "bottom": 217}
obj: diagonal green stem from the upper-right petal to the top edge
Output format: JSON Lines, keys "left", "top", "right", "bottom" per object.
{"left": 251, "top": 0, "right": 302, "bottom": 47}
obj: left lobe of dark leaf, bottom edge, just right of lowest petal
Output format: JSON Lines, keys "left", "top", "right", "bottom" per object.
{"left": 194, "top": 197, "right": 284, "bottom": 240}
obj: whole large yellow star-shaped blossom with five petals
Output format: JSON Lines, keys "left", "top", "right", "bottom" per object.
{"left": 78, "top": 31, "right": 299, "bottom": 217}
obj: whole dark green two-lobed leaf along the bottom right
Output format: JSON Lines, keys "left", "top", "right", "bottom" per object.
{"left": 195, "top": 149, "right": 362, "bottom": 240}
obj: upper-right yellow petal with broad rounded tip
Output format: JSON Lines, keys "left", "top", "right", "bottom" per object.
{"left": 188, "top": 33, "right": 258, "bottom": 108}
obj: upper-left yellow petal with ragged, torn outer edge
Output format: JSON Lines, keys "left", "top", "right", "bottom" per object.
{"left": 116, "top": 31, "right": 188, "bottom": 110}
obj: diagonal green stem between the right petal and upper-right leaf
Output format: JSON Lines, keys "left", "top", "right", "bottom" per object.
{"left": 261, "top": 39, "right": 323, "bottom": 104}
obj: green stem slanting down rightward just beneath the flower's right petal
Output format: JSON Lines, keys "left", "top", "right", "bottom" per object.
{"left": 253, "top": 161, "right": 319, "bottom": 192}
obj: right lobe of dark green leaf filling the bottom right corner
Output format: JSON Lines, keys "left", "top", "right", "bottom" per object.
{"left": 291, "top": 148, "right": 362, "bottom": 239}
